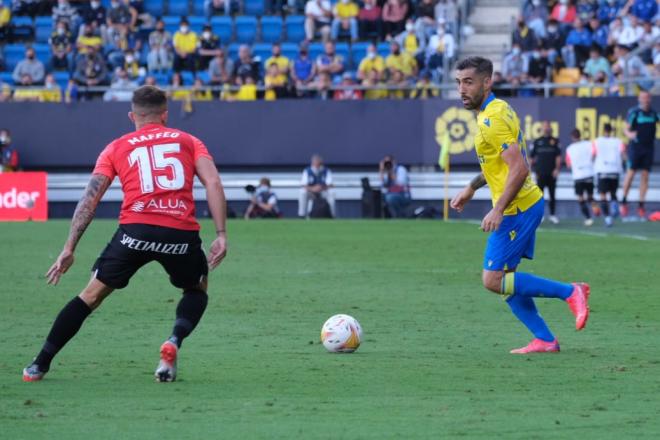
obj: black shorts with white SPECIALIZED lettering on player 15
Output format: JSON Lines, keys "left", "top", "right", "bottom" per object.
{"left": 92, "top": 224, "right": 209, "bottom": 289}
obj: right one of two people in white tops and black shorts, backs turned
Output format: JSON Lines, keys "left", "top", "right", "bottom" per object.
{"left": 593, "top": 123, "right": 626, "bottom": 227}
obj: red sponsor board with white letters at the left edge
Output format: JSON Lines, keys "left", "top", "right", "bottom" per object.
{"left": 0, "top": 173, "right": 48, "bottom": 221}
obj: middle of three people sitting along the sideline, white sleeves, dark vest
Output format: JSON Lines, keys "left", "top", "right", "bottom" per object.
{"left": 298, "top": 154, "right": 336, "bottom": 218}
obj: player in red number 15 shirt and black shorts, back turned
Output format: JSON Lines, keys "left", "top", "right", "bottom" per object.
{"left": 23, "top": 86, "right": 227, "bottom": 382}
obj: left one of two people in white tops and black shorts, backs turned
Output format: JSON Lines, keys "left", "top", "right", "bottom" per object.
{"left": 566, "top": 128, "right": 597, "bottom": 226}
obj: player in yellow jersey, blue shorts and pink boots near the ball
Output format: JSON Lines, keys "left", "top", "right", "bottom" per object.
{"left": 451, "top": 57, "right": 589, "bottom": 354}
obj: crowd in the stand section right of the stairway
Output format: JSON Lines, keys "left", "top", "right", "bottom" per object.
{"left": 495, "top": 0, "right": 660, "bottom": 96}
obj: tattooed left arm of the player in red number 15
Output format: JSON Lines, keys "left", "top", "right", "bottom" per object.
{"left": 46, "top": 174, "right": 112, "bottom": 284}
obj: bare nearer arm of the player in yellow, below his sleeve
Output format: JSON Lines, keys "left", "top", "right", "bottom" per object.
{"left": 481, "top": 144, "right": 529, "bottom": 232}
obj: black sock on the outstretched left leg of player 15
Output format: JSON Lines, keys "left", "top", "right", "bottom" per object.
{"left": 34, "top": 296, "right": 92, "bottom": 371}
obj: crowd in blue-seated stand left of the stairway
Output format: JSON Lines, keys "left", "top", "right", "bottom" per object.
{"left": 0, "top": 0, "right": 464, "bottom": 102}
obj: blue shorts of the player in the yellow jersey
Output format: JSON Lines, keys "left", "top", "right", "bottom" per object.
{"left": 484, "top": 199, "right": 545, "bottom": 270}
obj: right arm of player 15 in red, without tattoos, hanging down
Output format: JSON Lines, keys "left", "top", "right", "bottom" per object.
{"left": 195, "top": 157, "right": 227, "bottom": 269}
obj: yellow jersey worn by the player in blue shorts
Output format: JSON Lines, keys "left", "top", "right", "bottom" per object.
{"left": 474, "top": 93, "right": 543, "bottom": 215}
